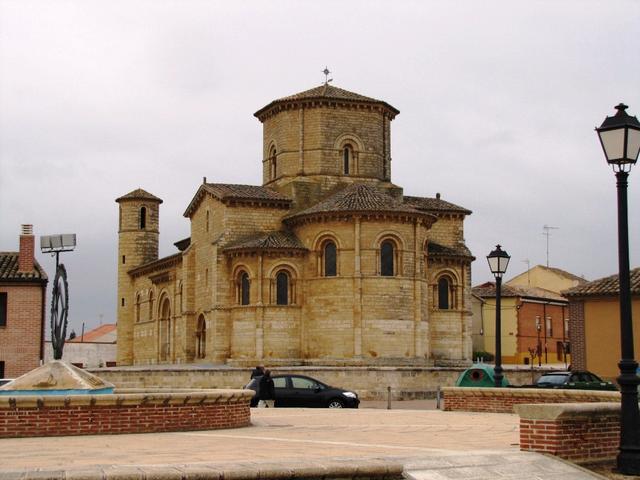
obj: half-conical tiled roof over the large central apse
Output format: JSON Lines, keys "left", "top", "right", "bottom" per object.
{"left": 286, "top": 183, "right": 433, "bottom": 223}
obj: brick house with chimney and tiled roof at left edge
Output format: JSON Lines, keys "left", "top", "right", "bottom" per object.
{"left": 0, "top": 225, "right": 47, "bottom": 378}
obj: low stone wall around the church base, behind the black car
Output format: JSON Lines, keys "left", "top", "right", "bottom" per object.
{"left": 92, "top": 364, "right": 539, "bottom": 400}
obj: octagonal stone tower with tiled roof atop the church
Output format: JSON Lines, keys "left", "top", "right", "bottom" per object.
{"left": 254, "top": 84, "right": 402, "bottom": 208}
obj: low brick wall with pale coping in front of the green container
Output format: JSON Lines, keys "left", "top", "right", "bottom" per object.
{"left": 442, "top": 387, "right": 620, "bottom": 413}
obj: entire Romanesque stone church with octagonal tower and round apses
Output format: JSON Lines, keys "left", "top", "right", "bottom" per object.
{"left": 116, "top": 83, "right": 474, "bottom": 366}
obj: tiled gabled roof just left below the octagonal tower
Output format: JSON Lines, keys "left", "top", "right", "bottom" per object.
{"left": 184, "top": 183, "right": 291, "bottom": 217}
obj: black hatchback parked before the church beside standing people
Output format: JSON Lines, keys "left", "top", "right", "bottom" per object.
{"left": 245, "top": 375, "right": 360, "bottom": 408}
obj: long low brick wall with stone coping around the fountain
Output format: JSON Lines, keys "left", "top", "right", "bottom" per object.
{"left": 0, "top": 390, "right": 253, "bottom": 438}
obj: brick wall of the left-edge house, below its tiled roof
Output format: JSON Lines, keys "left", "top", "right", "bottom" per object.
{"left": 0, "top": 284, "right": 43, "bottom": 378}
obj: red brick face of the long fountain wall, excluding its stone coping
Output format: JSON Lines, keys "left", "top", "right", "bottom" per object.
{"left": 0, "top": 398, "right": 250, "bottom": 438}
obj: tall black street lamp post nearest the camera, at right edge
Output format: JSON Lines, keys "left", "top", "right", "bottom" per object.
{"left": 596, "top": 103, "right": 640, "bottom": 475}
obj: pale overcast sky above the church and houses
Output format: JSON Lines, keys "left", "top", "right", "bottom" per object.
{"left": 0, "top": 0, "right": 640, "bottom": 333}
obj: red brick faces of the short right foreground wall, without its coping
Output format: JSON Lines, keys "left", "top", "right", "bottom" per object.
{"left": 520, "top": 413, "right": 620, "bottom": 461}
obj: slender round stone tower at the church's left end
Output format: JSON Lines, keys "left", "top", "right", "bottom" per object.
{"left": 116, "top": 188, "right": 162, "bottom": 365}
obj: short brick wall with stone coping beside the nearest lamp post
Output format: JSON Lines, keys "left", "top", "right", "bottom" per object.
{"left": 517, "top": 403, "right": 620, "bottom": 462}
